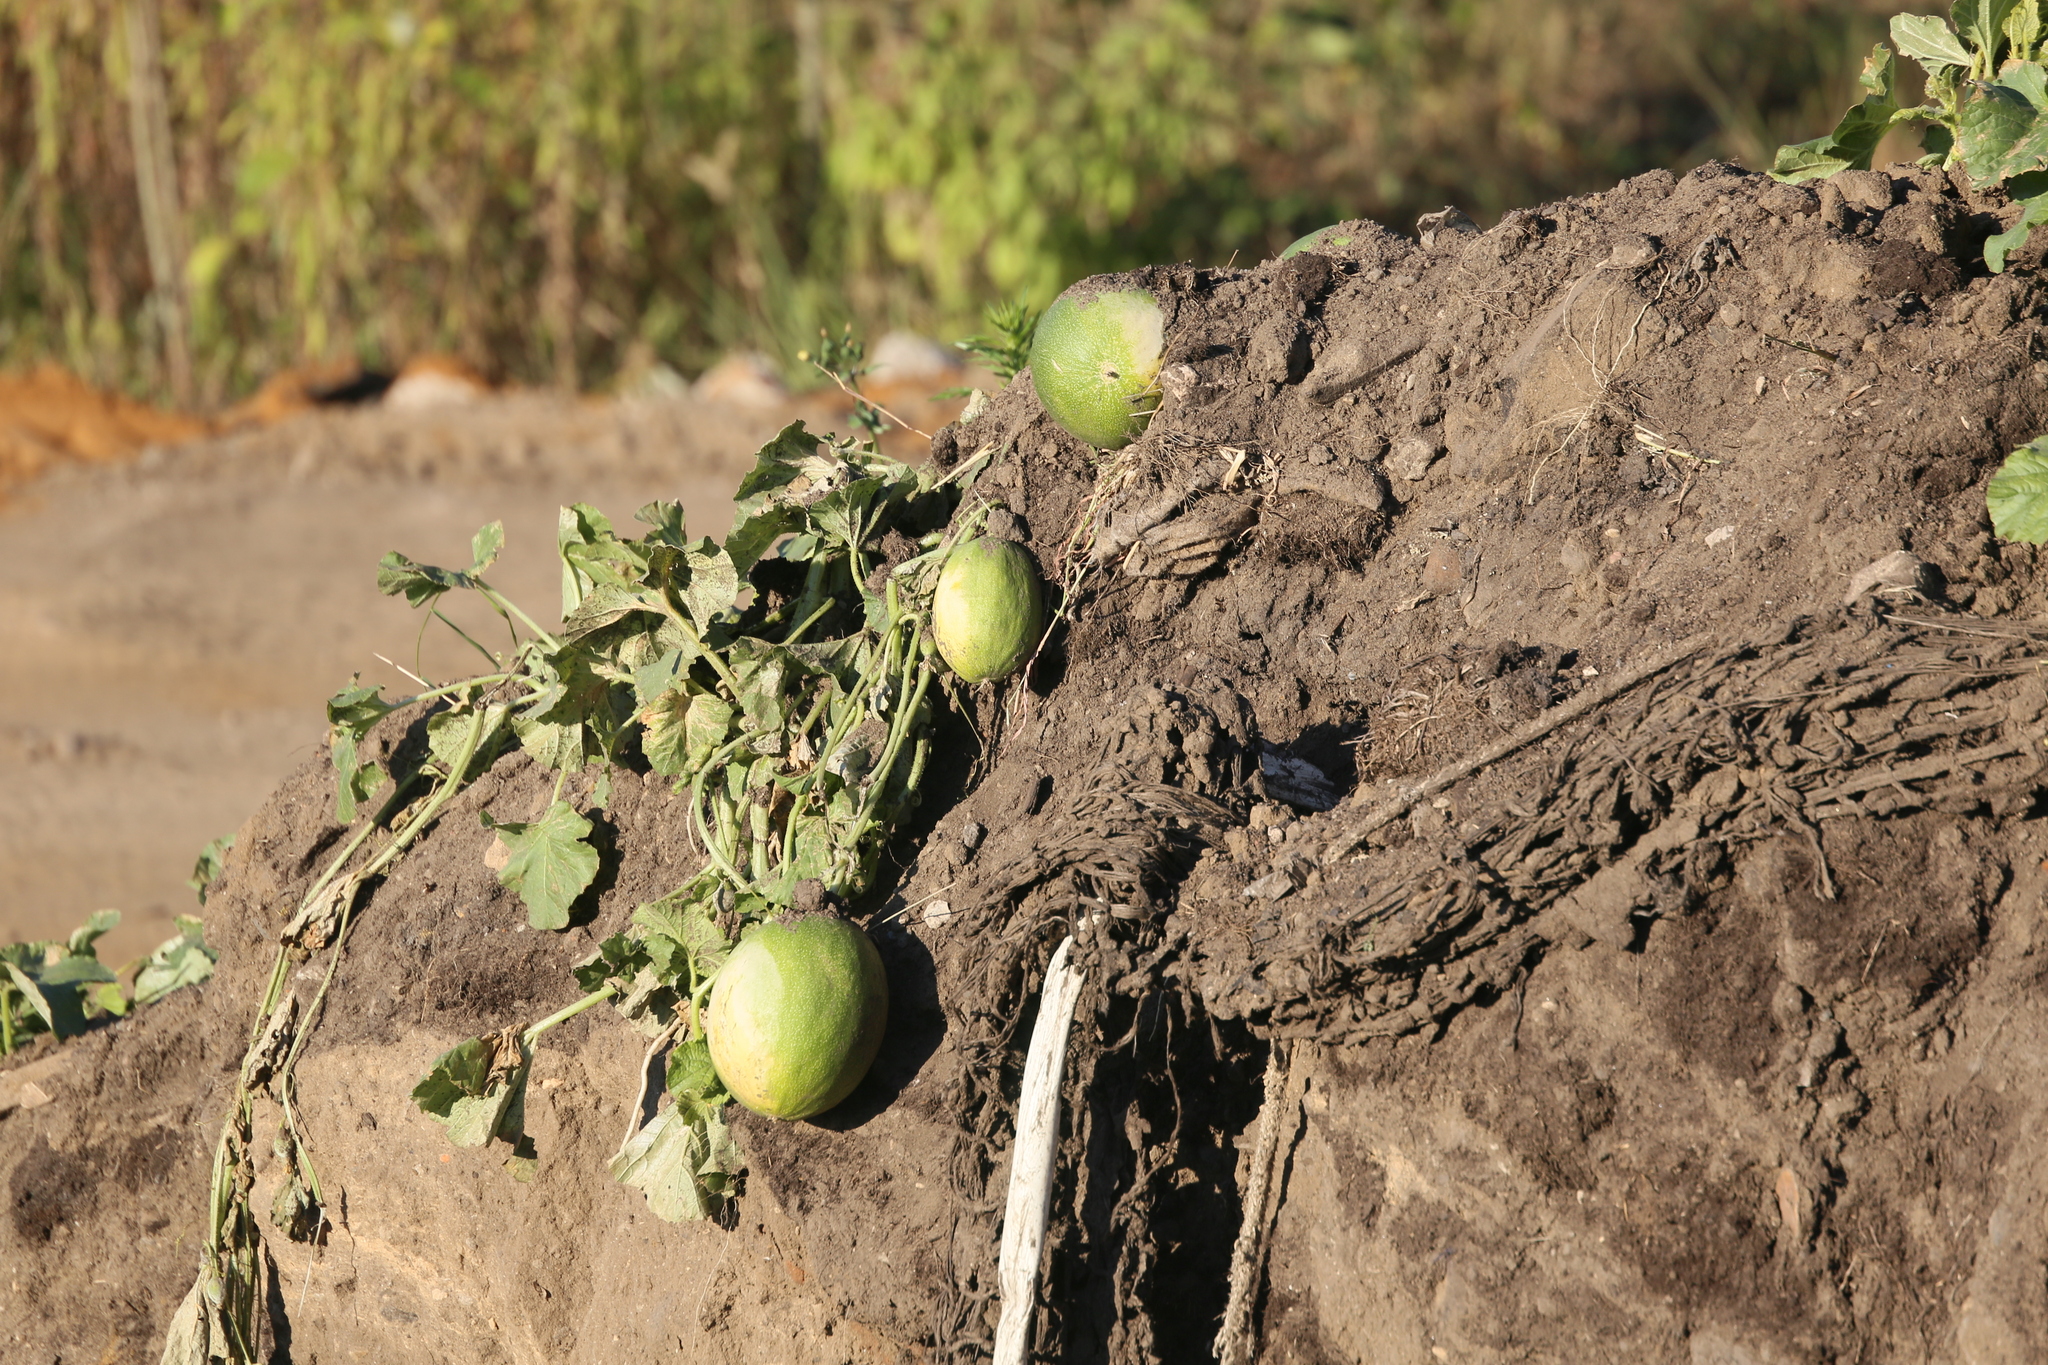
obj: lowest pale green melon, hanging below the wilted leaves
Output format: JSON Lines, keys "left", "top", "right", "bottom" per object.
{"left": 705, "top": 913, "right": 889, "bottom": 1119}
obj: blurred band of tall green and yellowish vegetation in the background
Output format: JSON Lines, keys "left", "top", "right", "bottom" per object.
{"left": 0, "top": 0, "right": 1896, "bottom": 403}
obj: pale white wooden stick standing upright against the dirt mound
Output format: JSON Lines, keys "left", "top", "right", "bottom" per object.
{"left": 993, "top": 937, "right": 1085, "bottom": 1365}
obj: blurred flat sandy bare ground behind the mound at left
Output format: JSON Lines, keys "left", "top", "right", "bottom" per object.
{"left": 0, "top": 395, "right": 795, "bottom": 962}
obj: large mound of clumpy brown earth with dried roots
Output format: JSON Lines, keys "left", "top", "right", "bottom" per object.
{"left": 0, "top": 166, "right": 2048, "bottom": 1365}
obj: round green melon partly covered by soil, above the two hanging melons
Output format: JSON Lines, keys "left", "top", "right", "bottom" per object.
{"left": 1030, "top": 276, "right": 1165, "bottom": 450}
